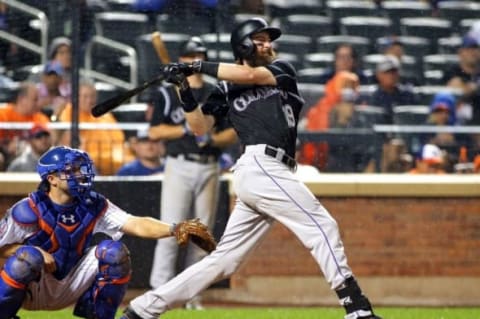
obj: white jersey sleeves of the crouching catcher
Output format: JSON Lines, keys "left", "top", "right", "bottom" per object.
{"left": 0, "top": 200, "right": 131, "bottom": 247}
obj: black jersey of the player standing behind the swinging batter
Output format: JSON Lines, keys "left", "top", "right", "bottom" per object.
{"left": 150, "top": 82, "right": 229, "bottom": 157}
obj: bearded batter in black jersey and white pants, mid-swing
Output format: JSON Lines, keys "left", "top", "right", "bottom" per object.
{"left": 122, "top": 18, "right": 380, "bottom": 319}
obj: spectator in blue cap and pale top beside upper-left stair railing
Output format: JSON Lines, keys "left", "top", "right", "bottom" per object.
{"left": 37, "top": 61, "right": 69, "bottom": 121}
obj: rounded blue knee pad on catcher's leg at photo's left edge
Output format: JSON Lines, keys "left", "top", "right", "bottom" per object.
{"left": 1, "top": 246, "right": 44, "bottom": 289}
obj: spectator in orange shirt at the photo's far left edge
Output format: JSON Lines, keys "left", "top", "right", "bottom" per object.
{"left": 0, "top": 82, "right": 49, "bottom": 169}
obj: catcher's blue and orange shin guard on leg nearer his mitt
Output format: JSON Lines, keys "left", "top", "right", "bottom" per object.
{"left": 73, "top": 240, "right": 131, "bottom": 319}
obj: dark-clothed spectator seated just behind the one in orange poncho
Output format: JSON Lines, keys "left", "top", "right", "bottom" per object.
{"left": 319, "top": 43, "right": 371, "bottom": 84}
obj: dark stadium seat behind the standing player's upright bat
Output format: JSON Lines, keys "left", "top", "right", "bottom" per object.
{"left": 135, "top": 33, "right": 190, "bottom": 82}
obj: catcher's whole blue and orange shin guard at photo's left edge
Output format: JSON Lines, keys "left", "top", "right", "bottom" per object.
{"left": 0, "top": 246, "right": 44, "bottom": 319}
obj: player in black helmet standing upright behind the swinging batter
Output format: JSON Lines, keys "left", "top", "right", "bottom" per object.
{"left": 149, "top": 37, "right": 237, "bottom": 308}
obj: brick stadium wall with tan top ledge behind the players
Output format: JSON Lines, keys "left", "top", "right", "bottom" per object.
{"left": 0, "top": 174, "right": 480, "bottom": 306}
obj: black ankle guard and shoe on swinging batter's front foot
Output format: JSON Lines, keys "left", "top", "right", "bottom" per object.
{"left": 336, "top": 277, "right": 381, "bottom": 319}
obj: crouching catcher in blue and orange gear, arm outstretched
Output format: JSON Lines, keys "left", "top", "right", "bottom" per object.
{"left": 0, "top": 146, "right": 203, "bottom": 319}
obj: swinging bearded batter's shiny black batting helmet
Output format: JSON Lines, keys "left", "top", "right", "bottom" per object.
{"left": 230, "top": 18, "right": 282, "bottom": 60}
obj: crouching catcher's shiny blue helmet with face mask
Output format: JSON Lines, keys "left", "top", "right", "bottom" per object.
{"left": 37, "top": 146, "right": 95, "bottom": 196}
